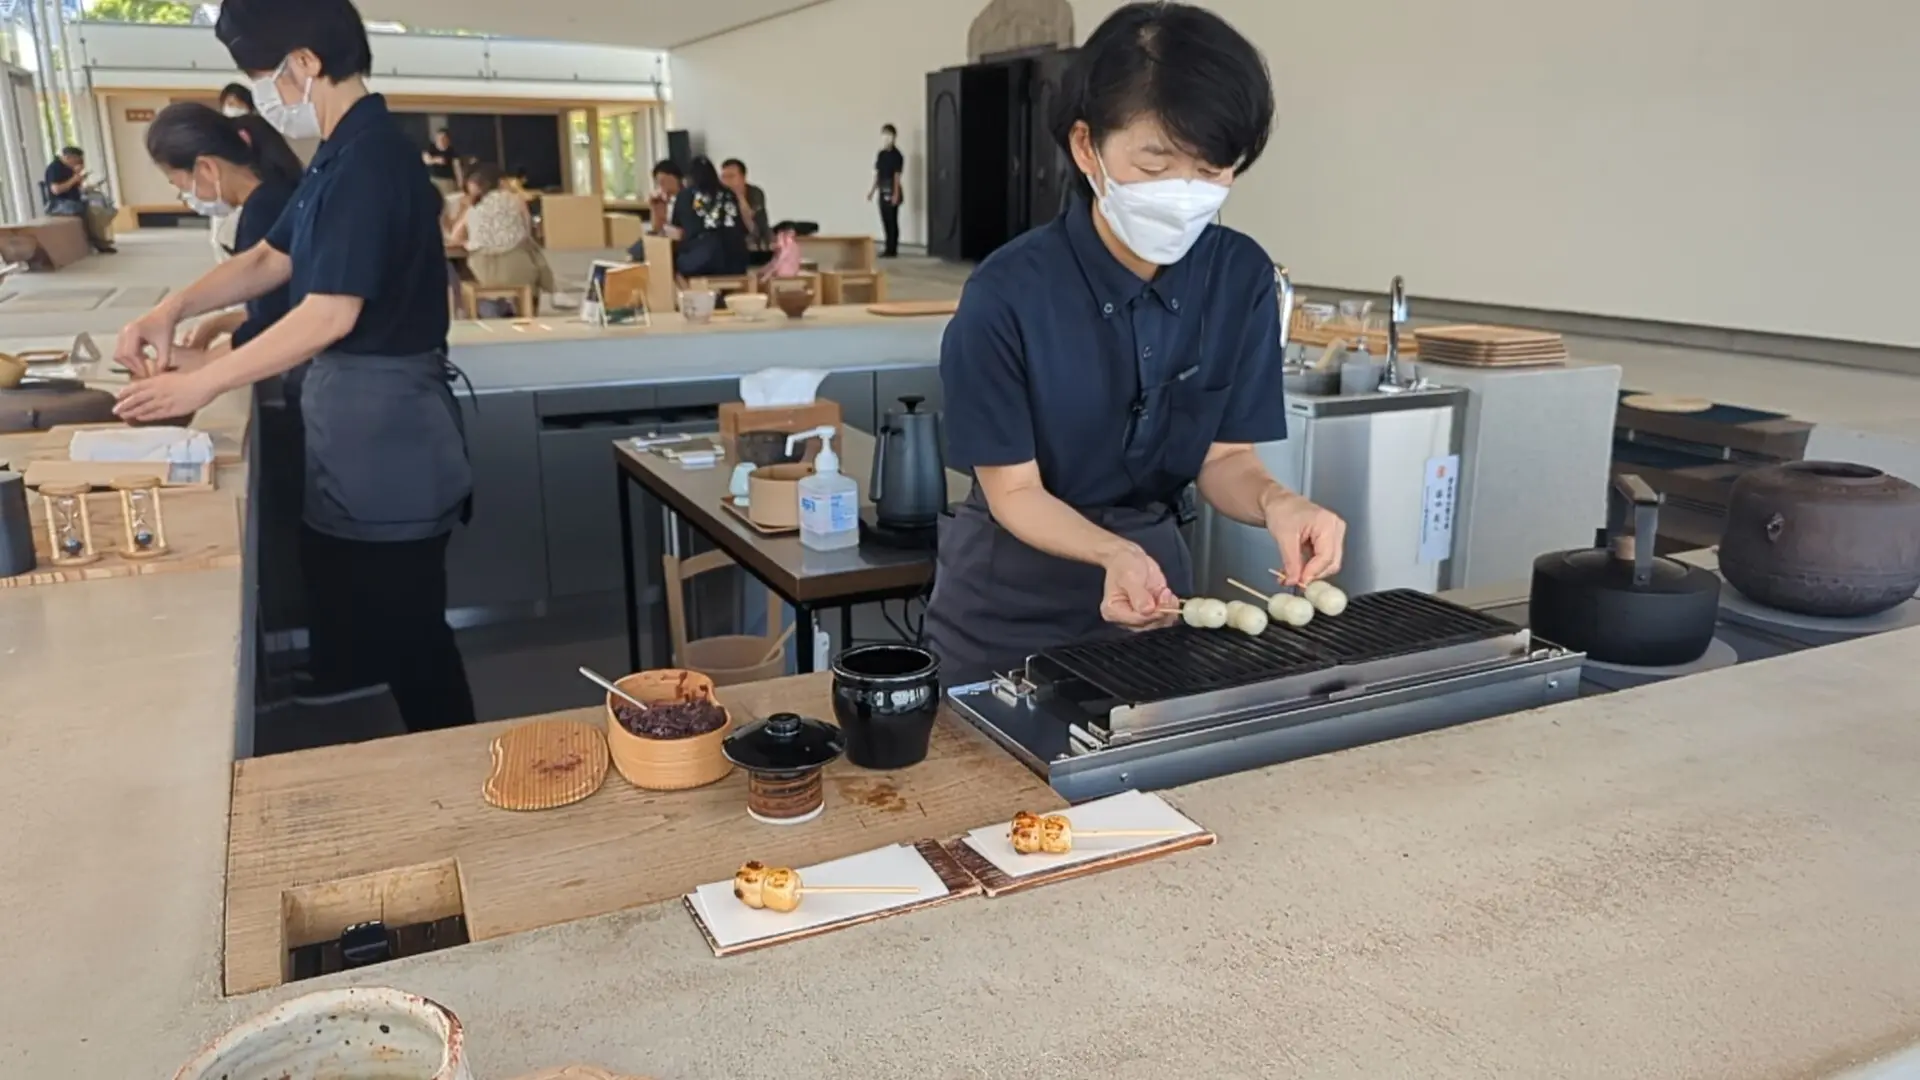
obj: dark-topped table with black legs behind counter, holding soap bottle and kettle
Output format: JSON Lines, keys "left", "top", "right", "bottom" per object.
{"left": 612, "top": 425, "right": 970, "bottom": 675}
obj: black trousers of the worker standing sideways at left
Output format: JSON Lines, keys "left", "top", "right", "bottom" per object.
{"left": 300, "top": 527, "right": 474, "bottom": 732}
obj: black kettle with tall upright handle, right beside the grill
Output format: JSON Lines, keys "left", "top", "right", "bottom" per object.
{"left": 1528, "top": 475, "right": 1720, "bottom": 667}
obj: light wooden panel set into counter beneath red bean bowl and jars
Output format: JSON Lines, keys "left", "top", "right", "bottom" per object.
{"left": 225, "top": 675, "right": 1066, "bottom": 994}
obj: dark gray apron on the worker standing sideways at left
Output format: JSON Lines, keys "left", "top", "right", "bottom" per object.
{"left": 300, "top": 352, "right": 474, "bottom": 542}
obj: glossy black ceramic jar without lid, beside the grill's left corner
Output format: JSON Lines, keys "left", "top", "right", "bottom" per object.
{"left": 833, "top": 646, "right": 941, "bottom": 771}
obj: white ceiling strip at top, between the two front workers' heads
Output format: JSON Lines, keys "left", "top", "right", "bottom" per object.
{"left": 359, "top": 0, "right": 828, "bottom": 48}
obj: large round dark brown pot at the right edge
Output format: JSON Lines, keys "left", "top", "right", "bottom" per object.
{"left": 1720, "top": 461, "right": 1920, "bottom": 619}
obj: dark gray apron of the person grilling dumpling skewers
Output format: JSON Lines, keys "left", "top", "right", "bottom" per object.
{"left": 927, "top": 486, "right": 1194, "bottom": 686}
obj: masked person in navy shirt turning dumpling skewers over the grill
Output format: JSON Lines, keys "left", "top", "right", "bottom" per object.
{"left": 927, "top": 4, "right": 1346, "bottom": 684}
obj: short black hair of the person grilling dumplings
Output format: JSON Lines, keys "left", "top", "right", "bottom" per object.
{"left": 1052, "top": 2, "right": 1275, "bottom": 194}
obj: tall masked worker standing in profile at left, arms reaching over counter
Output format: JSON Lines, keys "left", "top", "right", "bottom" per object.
{"left": 115, "top": 0, "right": 474, "bottom": 730}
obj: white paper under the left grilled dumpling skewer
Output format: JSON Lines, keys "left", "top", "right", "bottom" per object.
{"left": 689, "top": 844, "right": 947, "bottom": 949}
